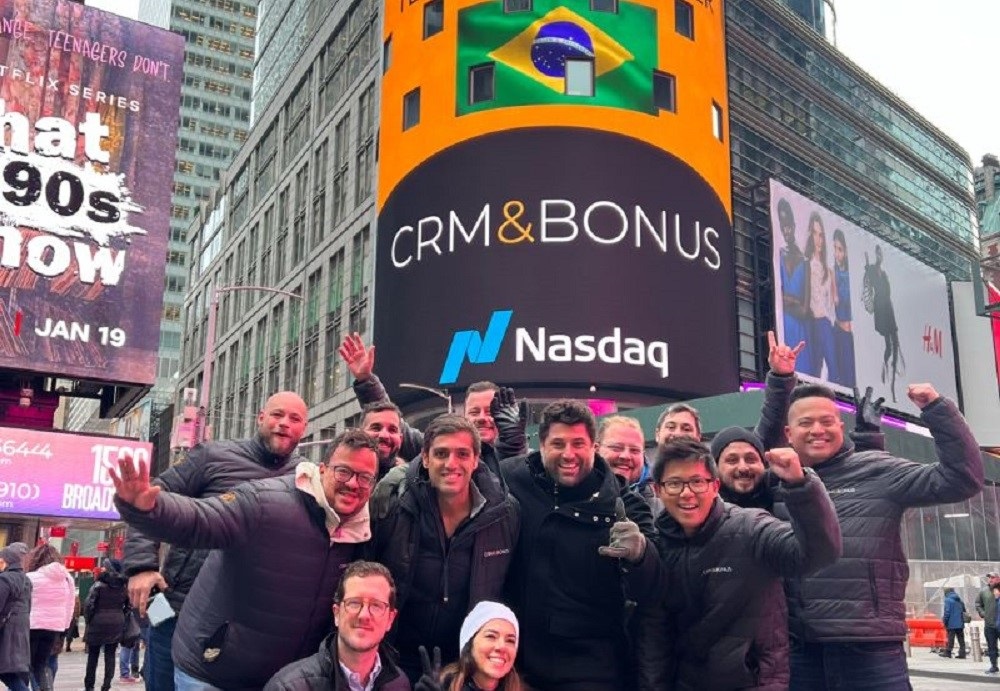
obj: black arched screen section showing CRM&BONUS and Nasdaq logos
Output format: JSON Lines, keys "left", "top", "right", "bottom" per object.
{"left": 375, "top": 128, "right": 737, "bottom": 402}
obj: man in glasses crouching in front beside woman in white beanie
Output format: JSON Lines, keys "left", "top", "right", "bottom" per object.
{"left": 264, "top": 561, "right": 410, "bottom": 691}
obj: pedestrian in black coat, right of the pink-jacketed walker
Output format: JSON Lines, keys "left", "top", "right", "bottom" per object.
{"left": 83, "top": 559, "right": 129, "bottom": 691}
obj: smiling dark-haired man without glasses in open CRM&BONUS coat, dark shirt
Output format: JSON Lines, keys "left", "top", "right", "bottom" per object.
{"left": 365, "top": 415, "right": 520, "bottom": 682}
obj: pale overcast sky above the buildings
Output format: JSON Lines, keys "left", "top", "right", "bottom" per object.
{"left": 87, "top": 0, "right": 1000, "bottom": 165}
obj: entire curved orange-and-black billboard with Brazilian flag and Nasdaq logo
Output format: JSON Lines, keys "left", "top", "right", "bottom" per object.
{"left": 374, "top": 0, "right": 738, "bottom": 402}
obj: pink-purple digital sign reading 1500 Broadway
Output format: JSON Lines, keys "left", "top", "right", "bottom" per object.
{"left": 0, "top": 427, "right": 153, "bottom": 520}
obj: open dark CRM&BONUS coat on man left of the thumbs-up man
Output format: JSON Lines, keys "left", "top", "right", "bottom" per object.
{"left": 365, "top": 459, "right": 520, "bottom": 669}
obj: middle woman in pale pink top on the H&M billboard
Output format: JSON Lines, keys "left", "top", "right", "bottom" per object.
{"left": 800, "top": 211, "right": 838, "bottom": 382}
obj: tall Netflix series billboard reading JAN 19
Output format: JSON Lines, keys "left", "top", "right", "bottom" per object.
{"left": 0, "top": 0, "right": 184, "bottom": 384}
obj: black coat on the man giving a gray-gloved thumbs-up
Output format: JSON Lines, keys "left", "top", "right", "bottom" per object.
{"left": 501, "top": 451, "right": 662, "bottom": 689}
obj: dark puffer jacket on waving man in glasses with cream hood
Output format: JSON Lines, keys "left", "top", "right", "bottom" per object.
{"left": 116, "top": 475, "right": 367, "bottom": 691}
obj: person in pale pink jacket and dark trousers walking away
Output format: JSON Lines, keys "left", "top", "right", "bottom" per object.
{"left": 24, "top": 545, "right": 76, "bottom": 691}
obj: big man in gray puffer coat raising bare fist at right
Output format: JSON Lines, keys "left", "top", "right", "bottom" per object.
{"left": 765, "top": 384, "right": 983, "bottom": 691}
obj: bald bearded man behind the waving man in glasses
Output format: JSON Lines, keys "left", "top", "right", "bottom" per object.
{"left": 124, "top": 391, "right": 309, "bottom": 691}
